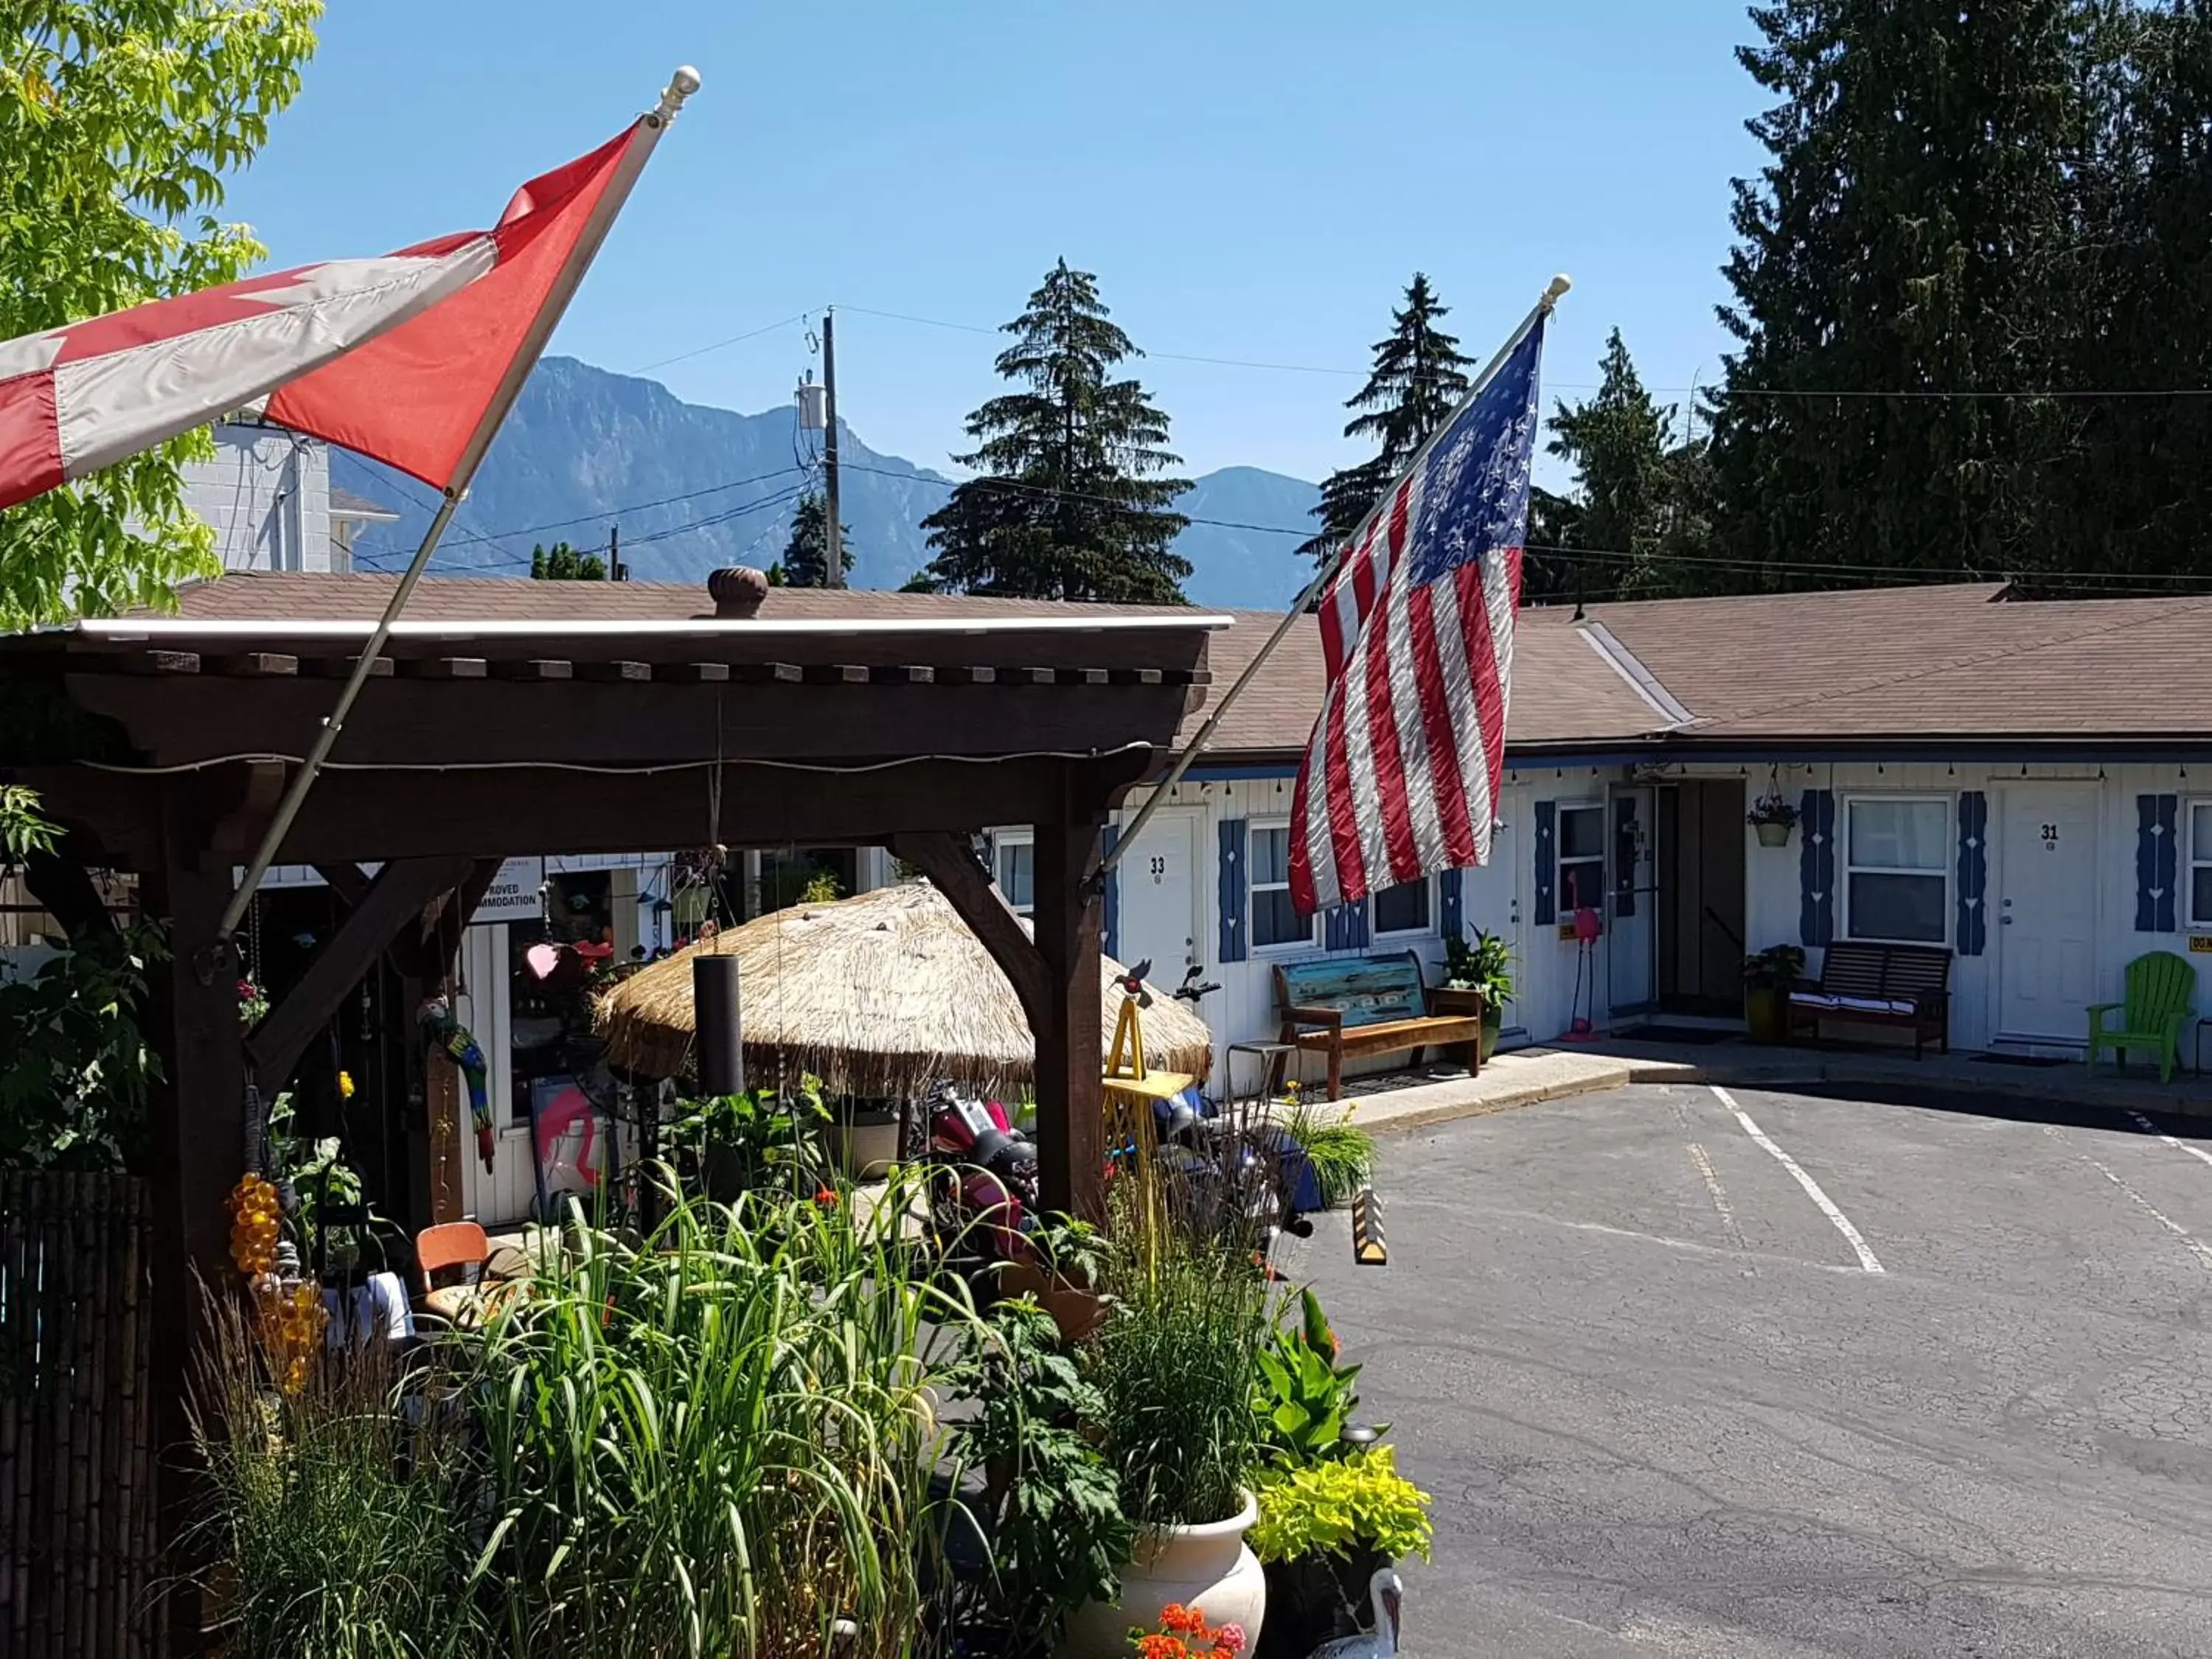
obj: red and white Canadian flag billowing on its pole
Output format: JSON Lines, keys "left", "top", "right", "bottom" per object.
{"left": 0, "top": 108, "right": 655, "bottom": 509}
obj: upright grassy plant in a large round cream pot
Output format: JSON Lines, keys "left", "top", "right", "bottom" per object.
{"left": 1062, "top": 1225, "right": 1270, "bottom": 1659}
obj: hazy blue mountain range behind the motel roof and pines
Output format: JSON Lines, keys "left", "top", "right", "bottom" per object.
{"left": 345, "top": 356, "right": 1318, "bottom": 608}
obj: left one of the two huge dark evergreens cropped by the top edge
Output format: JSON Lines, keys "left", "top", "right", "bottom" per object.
{"left": 1712, "top": 0, "right": 2081, "bottom": 586}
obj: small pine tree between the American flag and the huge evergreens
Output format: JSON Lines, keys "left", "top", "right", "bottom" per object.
{"left": 1548, "top": 330, "right": 1701, "bottom": 599}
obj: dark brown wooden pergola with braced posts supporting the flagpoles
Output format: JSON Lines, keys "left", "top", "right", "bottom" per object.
{"left": 0, "top": 577, "right": 1225, "bottom": 1531}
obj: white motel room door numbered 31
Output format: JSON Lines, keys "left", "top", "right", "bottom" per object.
{"left": 1997, "top": 783, "right": 2097, "bottom": 1042}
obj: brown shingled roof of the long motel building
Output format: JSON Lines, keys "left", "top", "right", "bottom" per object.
{"left": 125, "top": 571, "right": 2212, "bottom": 759}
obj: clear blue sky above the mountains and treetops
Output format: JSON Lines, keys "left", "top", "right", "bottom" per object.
{"left": 230, "top": 0, "right": 1759, "bottom": 478}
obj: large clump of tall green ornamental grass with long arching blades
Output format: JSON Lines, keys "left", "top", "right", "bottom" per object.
{"left": 478, "top": 1181, "right": 975, "bottom": 1659}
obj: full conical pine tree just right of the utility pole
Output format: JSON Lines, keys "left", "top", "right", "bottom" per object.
{"left": 916, "top": 270, "right": 1190, "bottom": 604}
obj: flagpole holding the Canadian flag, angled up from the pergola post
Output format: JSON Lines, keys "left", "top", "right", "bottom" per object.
{"left": 215, "top": 64, "right": 699, "bottom": 949}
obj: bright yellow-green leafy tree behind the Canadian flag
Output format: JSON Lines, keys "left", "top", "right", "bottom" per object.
{"left": 0, "top": 0, "right": 323, "bottom": 628}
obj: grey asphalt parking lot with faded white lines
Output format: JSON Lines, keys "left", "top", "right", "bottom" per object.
{"left": 1292, "top": 1084, "right": 2212, "bottom": 1659}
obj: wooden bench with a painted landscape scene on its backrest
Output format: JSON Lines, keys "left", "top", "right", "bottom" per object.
{"left": 1270, "top": 951, "right": 1482, "bottom": 1099}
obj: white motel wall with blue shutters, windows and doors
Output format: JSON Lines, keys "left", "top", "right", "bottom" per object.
{"left": 1097, "top": 759, "right": 2212, "bottom": 1088}
